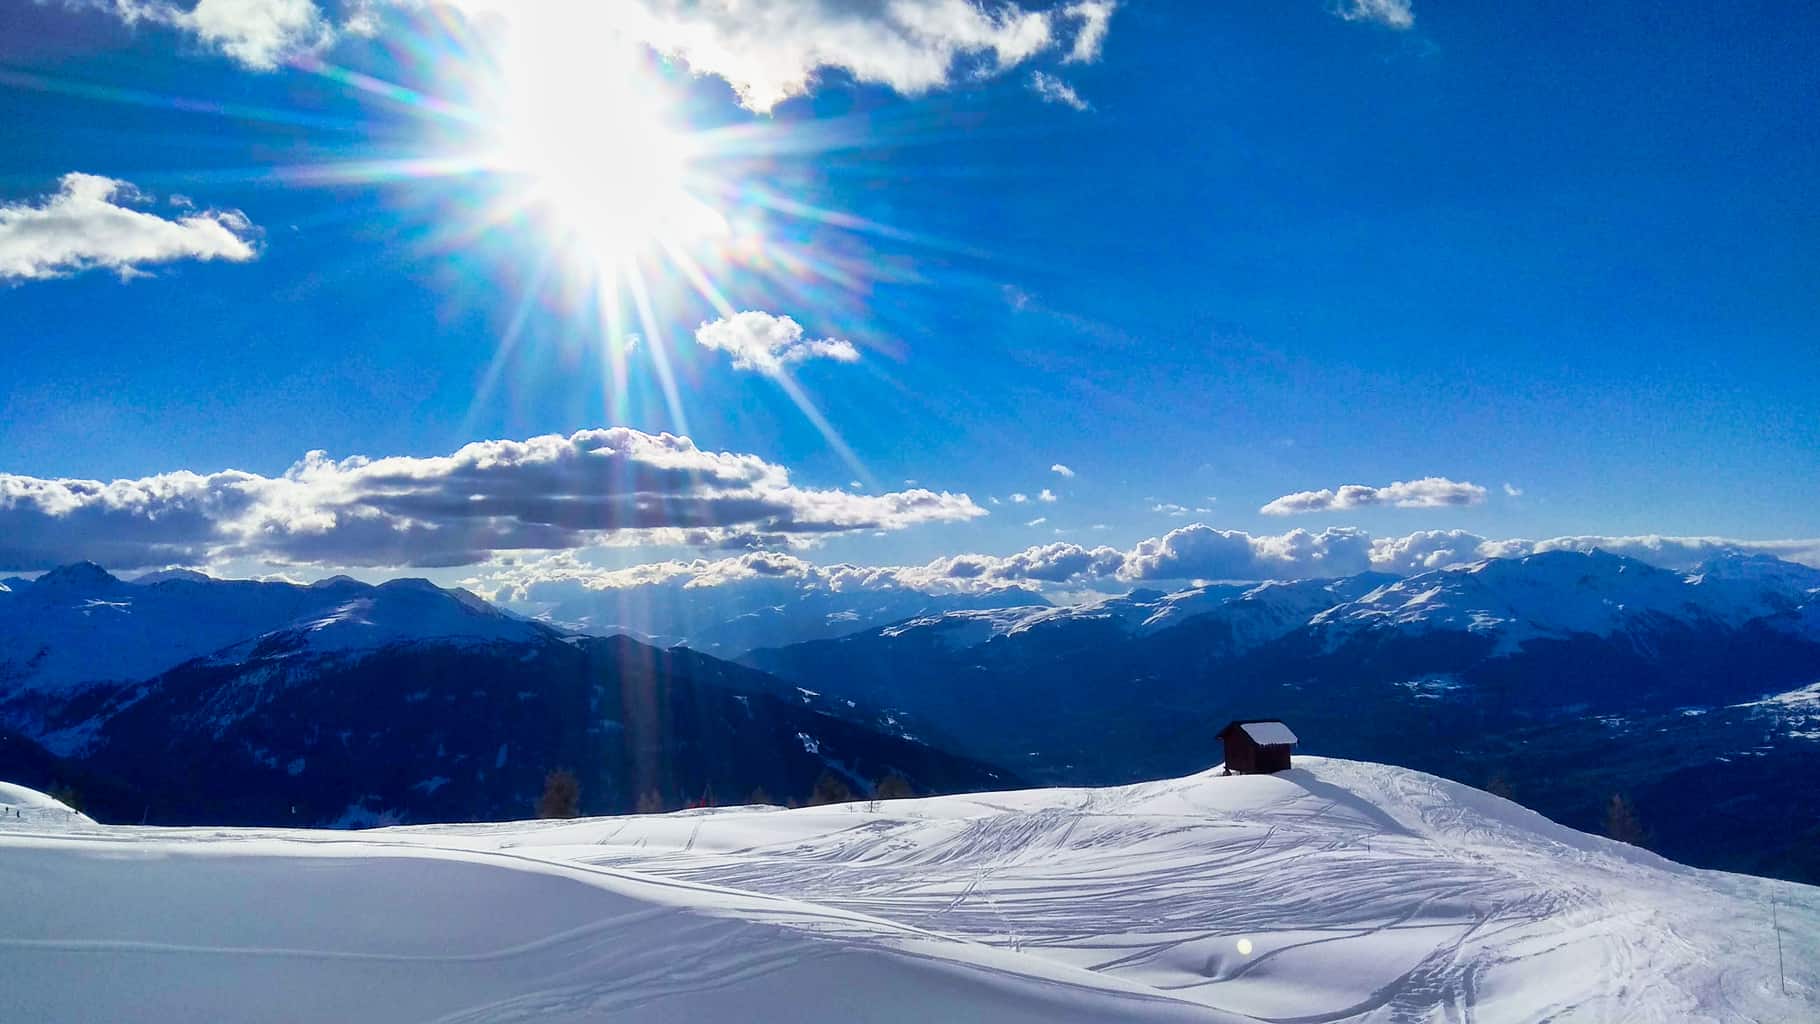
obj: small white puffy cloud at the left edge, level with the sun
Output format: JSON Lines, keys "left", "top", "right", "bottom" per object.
{"left": 0, "top": 173, "right": 258, "bottom": 280}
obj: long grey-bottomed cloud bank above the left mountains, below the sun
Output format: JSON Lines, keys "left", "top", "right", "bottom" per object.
{"left": 0, "top": 427, "right": 985, "bottom": 569}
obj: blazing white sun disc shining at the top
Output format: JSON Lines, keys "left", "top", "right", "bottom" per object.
{"left": 490, "top": 18, "right": 726, "bottom": 266}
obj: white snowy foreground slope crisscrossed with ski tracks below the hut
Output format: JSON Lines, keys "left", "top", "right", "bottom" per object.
{"left": 0, "top": 757, "right": 1820, "bottom": 1024}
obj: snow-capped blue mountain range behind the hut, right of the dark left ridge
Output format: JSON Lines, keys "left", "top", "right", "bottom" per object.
{"left": 741, "top": 551, "right": 1820, "bottom": 878}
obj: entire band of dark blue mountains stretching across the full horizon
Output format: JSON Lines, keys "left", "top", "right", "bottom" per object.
{"left": 0, "top": 551, "right": 1820, "bottom": 878}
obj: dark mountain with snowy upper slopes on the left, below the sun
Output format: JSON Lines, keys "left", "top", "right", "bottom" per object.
{"left": 0, "top": 564, "right": 1014, "bottom": 824}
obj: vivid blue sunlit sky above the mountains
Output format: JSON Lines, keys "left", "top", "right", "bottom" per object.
{"left": 0, "top": 0, "right": 1820, "bottom": 582}
